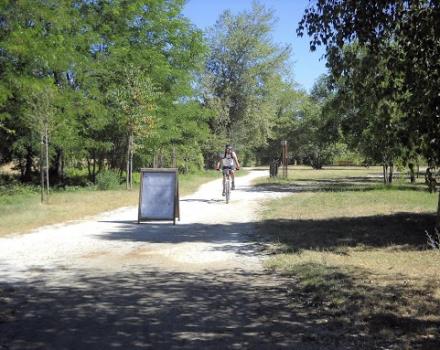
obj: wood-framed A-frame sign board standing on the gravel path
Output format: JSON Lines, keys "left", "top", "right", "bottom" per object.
{"left": 138, "top": 169, "right": 179, "bottom": 223}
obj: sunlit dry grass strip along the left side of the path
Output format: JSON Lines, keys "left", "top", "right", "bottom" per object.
{"left": 0, "top": 171, "right": 241, "bottom": 236}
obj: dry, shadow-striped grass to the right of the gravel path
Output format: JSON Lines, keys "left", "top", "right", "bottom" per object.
{"left": 257, "top": 168, "right": 440, "bottom": 349}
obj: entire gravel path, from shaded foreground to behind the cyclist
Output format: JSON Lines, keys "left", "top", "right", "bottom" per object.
{"left": 0, "top": 171, "right": 336, "bottom": 349}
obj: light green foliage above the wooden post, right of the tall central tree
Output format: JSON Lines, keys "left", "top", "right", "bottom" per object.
{"left": 259, "top": 76, "right": 340, "bottom": 169}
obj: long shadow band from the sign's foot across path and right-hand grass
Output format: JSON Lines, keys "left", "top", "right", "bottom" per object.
{"left": 99, "top": 213, "right": 435, "bottom": 251}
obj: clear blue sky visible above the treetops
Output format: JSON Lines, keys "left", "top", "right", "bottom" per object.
{"left": 183, "top": 0, "right": 327, "bottom": 91}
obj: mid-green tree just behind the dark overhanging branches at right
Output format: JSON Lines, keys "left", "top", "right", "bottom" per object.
{"left": 324, "top": 43, "right": 410, "bottom": 184}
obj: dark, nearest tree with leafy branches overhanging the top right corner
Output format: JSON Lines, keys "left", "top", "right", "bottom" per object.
{"left": 297, "top": 0, "right": 440, "bottom": 228}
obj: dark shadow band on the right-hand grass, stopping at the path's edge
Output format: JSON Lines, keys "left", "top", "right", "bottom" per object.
{"left": 258, "top": 213, "right": 435, "bottom": 251}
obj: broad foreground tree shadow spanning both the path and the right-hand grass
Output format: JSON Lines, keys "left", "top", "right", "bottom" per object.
{"left": 0, "top": 264, "right": 440, "bottom": 349}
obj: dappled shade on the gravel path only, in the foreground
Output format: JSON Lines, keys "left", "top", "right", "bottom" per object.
{"left": 0, "top": 269, "right": 310, "bottom": 349}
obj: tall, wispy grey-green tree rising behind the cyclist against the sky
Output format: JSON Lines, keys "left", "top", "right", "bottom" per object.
{"left": 204, "top": 4, "right": 290, "bottom": 154}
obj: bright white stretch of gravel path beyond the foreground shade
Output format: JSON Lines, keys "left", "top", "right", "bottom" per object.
{"left": 0, "top": 171, "right": 286, "bottom": 282}
